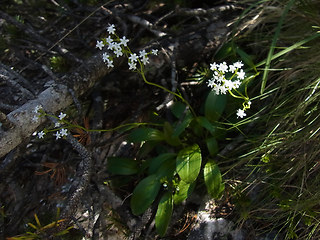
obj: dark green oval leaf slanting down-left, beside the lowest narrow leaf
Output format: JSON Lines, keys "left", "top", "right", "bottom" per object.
{"left": 130, "top": 174, "right": 161, "bottom": 215}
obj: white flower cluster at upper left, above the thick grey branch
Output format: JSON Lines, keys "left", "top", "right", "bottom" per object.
{"left": 96, "top": 24, "right": 158, "bottom": 70}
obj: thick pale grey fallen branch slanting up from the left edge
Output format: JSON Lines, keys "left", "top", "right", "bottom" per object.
{"left": 0, "top": 54, "right": 110, "bottom": 157}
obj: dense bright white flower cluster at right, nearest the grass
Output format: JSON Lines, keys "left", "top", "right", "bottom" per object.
{"left": 208, "top": 61, "right": 245, "bottom": 95}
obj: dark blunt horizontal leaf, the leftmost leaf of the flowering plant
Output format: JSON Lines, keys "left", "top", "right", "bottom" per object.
{"left": 107, "top": 157, "right": 139, "bottom": 175}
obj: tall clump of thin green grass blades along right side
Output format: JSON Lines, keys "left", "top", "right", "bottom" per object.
{"left": 226, "top": 0, "right": 320, "bottom": 239}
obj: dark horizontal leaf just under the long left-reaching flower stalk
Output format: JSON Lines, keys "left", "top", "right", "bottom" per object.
{"left": 128, "top": 127, "right": 164, "bottom": 143}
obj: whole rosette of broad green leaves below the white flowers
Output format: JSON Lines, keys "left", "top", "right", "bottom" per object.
{"left": 108, "top": 93, "right": 226, "bottom": 236}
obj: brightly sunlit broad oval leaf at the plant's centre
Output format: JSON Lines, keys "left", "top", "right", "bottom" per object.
{"left": 176, "top": 144, "right": 202, "bottom": 183}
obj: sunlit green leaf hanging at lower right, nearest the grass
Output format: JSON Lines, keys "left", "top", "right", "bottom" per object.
{"left": 203, "top": 160, "right": 224, "bottom": 198}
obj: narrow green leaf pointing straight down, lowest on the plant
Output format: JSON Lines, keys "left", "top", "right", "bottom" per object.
{"left": 155, "top": 192, "right": 173, "bottom": 236}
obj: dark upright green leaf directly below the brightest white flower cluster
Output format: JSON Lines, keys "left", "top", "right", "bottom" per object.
{"left": 204, "top": 91, "right": 227, "bottom": 122}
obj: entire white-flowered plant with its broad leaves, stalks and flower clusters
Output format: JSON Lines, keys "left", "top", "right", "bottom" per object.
{"left": 35, "top": 24, "right": 255, "bottom": 236}
